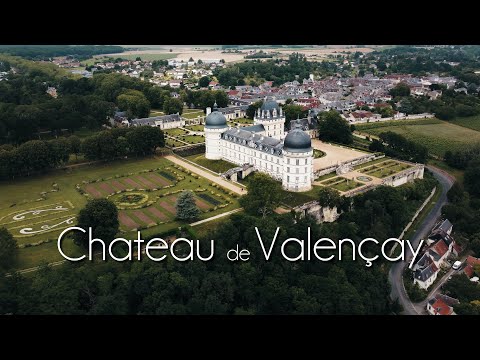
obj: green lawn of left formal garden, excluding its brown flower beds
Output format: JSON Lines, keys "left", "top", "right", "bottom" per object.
{"left": 0, "top": 158, "right": 239, "bottom": 269}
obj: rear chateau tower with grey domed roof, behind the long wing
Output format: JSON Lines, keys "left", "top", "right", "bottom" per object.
{"left": 253, "top": 99, "right": 285, "bottom": 140}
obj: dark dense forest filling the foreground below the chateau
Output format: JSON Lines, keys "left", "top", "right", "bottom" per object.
{"left": 0, "top": 174, "right": 435, "bottom": 314}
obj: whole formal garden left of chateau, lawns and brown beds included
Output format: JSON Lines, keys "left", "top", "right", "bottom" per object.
{"left": 0, "top": 158, "right": 239, "bottom": 269}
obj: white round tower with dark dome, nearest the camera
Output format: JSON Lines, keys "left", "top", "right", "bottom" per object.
{"left": 282, "top": 123, "right": 313, "bottom": 191}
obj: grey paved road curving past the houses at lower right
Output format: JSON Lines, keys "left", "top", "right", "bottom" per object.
{"left": 388, "top": 166, "right": 455, "bottom": 315}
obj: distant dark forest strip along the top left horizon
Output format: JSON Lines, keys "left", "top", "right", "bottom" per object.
{"left": 0, "top": 45, "right": 125, "bottom": 60}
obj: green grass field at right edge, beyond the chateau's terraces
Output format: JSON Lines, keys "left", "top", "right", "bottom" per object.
{"left": 356, "top": 119, "right": 480, "bottom": 157}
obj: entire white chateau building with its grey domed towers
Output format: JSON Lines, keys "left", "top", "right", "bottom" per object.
{"left": 205, "top": 100, "right": 314, "bottom": 191}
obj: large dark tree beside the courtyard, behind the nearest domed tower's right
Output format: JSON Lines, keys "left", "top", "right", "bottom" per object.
{"left": 318, "top": 110, "right": 353, "bottom": 144}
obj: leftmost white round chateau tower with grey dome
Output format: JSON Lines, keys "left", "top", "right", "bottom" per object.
{"left": 205, "top": 102, "right": 228, "bottom": 160}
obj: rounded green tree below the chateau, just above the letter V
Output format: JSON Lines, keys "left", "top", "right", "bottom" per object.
{"left": 240, "top": 173, "right": 283, "bottom": 217}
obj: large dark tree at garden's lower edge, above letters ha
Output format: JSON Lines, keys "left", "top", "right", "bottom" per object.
{"left": 74, "top": 198, "right": 119, "bottom": 246}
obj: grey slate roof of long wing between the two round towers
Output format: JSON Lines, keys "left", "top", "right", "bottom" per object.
{"left": 222, "top": 125, "right": 283, "bottom": 156}
